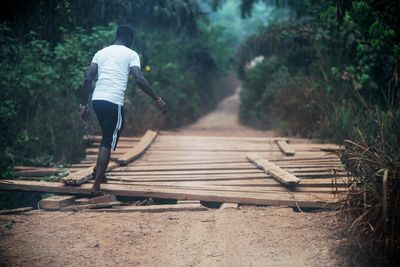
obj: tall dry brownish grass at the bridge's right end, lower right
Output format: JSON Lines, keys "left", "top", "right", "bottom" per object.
{"left": 339, "top": 111, "right": 400, "bottom": 266}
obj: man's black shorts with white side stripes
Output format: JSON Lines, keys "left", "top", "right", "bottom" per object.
{"left": 92, "top": 100, "right": 124, "bottom": 150}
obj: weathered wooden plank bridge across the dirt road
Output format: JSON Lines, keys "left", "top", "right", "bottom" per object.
{"left": 0, "top": 131, "right": 348, "bottom": 208}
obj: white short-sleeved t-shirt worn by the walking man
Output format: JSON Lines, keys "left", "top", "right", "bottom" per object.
{"left": 92, "top": 45, "right": 140, "bottom": 106}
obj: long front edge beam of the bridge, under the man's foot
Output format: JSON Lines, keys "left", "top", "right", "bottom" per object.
{"left": 0, "top": 180, "right": 335, "bottom": 208}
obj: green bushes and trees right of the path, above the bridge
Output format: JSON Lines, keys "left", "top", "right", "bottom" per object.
{"left": 238, "top": 1, "right": 399, "bottom": 141}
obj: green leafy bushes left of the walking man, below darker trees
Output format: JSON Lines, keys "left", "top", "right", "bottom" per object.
{"left": 0, "top": 25, "right": 112, "bottom": 172}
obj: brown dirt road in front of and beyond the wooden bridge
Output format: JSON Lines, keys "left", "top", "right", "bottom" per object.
{"left": 0, "top": 89, "right": 343, "bottom": 267}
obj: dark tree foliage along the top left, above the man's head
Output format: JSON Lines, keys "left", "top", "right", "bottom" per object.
{"left": 0, "top": 0, "right": 201, "bottom": 43}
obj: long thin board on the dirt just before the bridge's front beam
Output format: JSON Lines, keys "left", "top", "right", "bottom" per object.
{"left": 88, "top": 203, "right": 208, "bottom": 215}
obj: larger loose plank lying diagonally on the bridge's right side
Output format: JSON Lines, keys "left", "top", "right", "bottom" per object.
{"left": 246, "top": 154, "right": 300, "bottom": 185}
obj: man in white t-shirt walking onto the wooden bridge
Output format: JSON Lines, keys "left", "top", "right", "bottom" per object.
{"left": 80, "top": 25, "right": 167, "bottom": 194}
